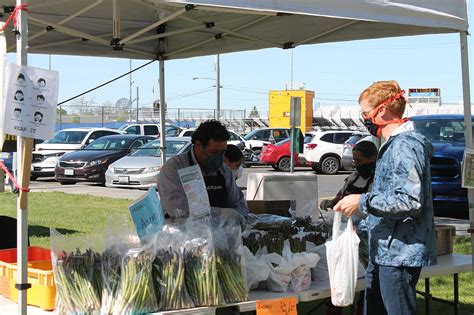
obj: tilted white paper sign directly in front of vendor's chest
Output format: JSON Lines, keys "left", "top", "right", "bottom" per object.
{"left": 178, "top": 165, "right": 211, "bottom": 217}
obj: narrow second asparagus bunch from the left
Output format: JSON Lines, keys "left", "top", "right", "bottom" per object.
{"left": 101, "top": 248, "right": 122, "bottom": 314}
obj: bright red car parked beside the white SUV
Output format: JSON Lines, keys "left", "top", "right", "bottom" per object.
{"left": 260, "top": 138, "right": 308, "bottom": 172}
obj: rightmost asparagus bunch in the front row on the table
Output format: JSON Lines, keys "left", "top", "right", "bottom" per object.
{"left": 216, "top": 250, "right": 248, "bottom": 303}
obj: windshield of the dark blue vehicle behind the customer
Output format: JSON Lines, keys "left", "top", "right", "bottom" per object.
{"left": 414, "top": 119, "right": 465, "bottom": 142}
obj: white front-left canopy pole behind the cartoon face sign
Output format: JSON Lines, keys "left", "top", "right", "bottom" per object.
{"left": 16, "top": 0, "right": 33, "bottom": 314}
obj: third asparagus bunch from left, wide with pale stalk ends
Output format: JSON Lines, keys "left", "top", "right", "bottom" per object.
{"left": 113, "top": 251, "right": 158, "bottom": 314}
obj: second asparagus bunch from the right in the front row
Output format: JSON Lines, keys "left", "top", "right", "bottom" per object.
{"left": 184, "top": 239, "right": 220, "bottom": 306}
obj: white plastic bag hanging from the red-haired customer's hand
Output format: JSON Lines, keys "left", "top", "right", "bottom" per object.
{"left": 326, "top": 211, "right": 360, "bottom": 306}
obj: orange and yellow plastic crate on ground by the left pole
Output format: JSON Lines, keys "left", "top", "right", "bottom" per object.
{"left": 0, "top": 246, "right": 56, "bottom": 310}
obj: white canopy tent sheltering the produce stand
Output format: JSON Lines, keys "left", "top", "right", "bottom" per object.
{"left": 0, "top": 0, "right": 474, "bottom": 313}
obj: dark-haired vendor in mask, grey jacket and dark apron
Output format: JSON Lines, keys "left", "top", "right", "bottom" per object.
{"left": 158, "top": 120, "right": 248, "bottom": 221}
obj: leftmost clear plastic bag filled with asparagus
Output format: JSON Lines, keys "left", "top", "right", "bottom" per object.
{"left": 50, "top": 228, "right": 102, "bottom": 314}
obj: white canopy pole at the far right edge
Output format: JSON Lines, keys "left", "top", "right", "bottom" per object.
{"left": 460, "top": 32, "right": 474, "bottom": 265}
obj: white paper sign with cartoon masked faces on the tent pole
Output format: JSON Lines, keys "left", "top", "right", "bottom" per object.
{"left": 3, "top": 64, "right": 59, "bottom": 140}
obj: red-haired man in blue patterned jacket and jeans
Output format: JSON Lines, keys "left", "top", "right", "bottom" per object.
{"left": 334, "top": 81, "right": 436, "bottom": 315}
